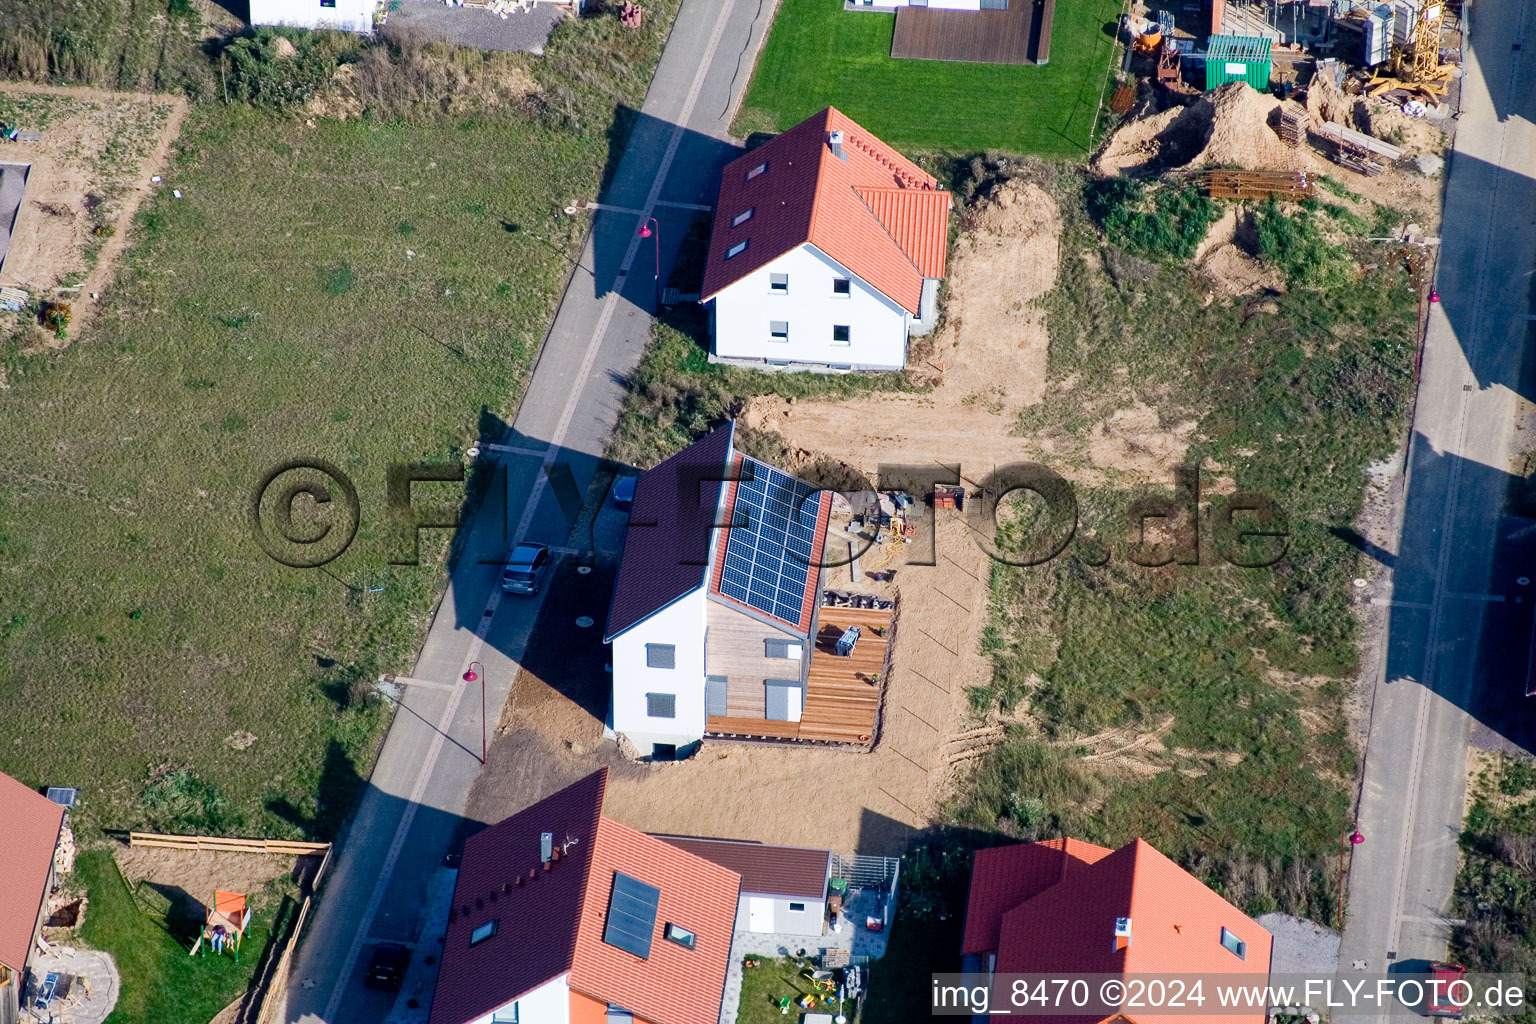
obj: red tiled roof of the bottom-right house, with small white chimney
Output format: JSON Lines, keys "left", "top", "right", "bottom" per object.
{"left": 960, "top": 838, "right": 1273, "bottom": 1024}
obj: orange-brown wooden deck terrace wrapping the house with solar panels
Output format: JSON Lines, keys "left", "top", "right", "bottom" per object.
{"left": 705, "top": 606, "right": 895, "bottom": 748}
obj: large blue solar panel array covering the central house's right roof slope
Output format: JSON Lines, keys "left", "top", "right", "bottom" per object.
{"left": 720, "top": 459, "right": 820, "bottom": 623}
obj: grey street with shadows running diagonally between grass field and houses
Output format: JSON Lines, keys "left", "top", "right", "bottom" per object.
{"left": 281, "top": 0, "right": 771, "bottom": 1024}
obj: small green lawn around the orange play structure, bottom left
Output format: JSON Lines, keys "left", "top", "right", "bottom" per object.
{"left": 74, "top": 849, "right": 290, "bottom": 1024}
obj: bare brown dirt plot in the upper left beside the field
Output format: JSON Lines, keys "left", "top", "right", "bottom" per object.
{"left": 0, "top": 84, "right": 187, "bottom": 339}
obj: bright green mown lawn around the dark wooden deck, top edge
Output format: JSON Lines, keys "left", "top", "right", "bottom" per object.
{"left": 734, "top": 0, "right": 1120, "bottom": 157}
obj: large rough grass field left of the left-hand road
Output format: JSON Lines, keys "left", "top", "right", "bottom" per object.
{"left": 0, "top": 5, "right": 673, "bottom": 838}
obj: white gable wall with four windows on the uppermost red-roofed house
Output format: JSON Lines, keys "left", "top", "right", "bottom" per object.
{"left": 714, "top": 244, "right": 909, "bottom": 370}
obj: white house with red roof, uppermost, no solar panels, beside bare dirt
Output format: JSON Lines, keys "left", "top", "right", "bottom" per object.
{"left": 702, "top": 107, "right": 952, "bottom": 372}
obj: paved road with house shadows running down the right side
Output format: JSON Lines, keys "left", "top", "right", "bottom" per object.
{"left": 1339, "top": 0, "right": 1536, "bottom": 1016}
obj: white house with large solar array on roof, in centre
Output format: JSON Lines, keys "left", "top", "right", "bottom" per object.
{"left": 604, "top": 424, "right": 847, "bottom": 758}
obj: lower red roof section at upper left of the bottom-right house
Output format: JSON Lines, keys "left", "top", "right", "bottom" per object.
{"left": 960, "top": 840, "right": 1111, "bottom": 953}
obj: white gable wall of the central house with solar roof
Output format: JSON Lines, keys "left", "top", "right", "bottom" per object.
{"left": 613, "top": 583, "right": 707, "bottom": 754}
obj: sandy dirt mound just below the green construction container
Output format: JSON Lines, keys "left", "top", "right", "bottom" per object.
{"left": 1095, "top": 81, "right": 1318, "bottom": 175}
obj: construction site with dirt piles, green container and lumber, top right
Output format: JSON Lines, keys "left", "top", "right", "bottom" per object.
{"left": 1112, "top": 0, "right": 1462, "bottom": 210}
